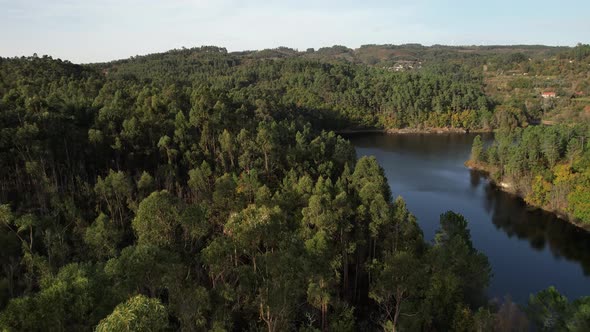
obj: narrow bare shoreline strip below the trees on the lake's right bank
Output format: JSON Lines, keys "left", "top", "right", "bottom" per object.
{"left": 465, "top": 160, "right": 590, "bottom": 232}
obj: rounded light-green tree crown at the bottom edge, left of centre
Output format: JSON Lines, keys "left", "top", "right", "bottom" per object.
{"left": 96, "top": 295, "right": 168, "bottom": 332}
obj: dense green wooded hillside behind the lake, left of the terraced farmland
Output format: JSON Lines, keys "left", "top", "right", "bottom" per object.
{"left": 89, "top": 47, "right": 494, "bottom": 129}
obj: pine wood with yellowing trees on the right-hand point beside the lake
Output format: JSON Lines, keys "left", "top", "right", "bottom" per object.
{"left": 467, "top": 123, "right": 590, "bottom": 228}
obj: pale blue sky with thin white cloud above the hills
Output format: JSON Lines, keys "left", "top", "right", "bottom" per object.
{"left": 0, "top": 0, "right": 590, "bottom": 63}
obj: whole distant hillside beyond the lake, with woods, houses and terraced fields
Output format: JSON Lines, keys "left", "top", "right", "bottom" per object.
{"left": 94, "top": 44, "right": 590, "bottom": 130}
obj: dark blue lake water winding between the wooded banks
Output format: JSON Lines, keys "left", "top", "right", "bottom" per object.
{"left": 348, "top": 134, "right": 590, "bottom": 303}
